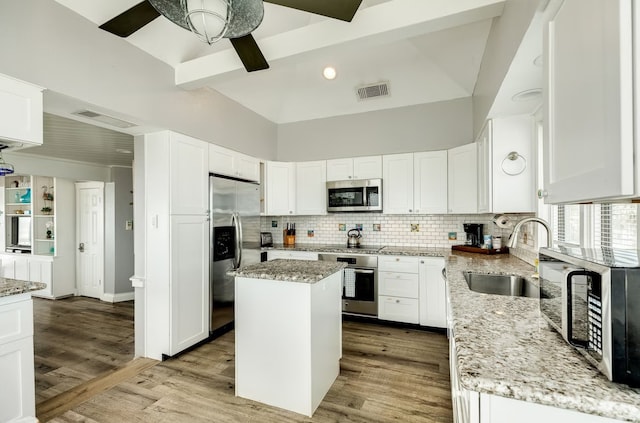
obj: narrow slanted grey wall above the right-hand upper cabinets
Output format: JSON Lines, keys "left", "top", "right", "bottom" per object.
{"left": 473, "top": 0, "right": 542, "bottom": 139}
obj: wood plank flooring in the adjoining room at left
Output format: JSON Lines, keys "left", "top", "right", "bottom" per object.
{"left": 33, "top": 297, "right": 134, "bottom": 404}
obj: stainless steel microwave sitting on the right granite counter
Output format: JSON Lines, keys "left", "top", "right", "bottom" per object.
{"left": 539, "top": 248, "right": 640, "bottom": 387}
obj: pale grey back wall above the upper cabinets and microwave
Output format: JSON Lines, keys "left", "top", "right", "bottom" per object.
{"left": 278, "top": 98, "right": 473, "bottom": 161}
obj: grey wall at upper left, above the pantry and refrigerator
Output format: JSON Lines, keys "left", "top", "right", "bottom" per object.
{"left": 0, "top": 0, "right": 277, "bottom": 159}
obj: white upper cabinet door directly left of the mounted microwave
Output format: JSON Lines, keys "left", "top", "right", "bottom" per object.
{"left": 295, "top": 160, "right": 327, "bottom": 215}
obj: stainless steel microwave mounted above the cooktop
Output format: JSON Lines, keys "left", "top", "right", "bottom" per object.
{"left": 327, "top": 179, "right": 382, "bottom": 212}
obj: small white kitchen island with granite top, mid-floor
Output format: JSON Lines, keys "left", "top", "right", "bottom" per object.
{"left": 231, "top": 260, "right": 345, "bottom": 417}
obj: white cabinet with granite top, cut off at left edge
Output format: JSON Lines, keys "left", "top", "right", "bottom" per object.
{"left": 0, "top": 278, "right": 46, "bottom": 423}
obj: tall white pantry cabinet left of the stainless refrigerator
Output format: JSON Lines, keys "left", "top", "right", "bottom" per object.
{"left": 144, "top": 131, "right": 209, "bottom": 359}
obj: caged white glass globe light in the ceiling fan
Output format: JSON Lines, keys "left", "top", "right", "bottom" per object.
{"left": 180, "top": 0, "right": 233, "bottom": 44}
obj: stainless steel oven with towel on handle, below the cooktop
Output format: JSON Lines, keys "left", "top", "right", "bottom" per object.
{"left": 319, "top": 253, "right": 378, "bottom": 317}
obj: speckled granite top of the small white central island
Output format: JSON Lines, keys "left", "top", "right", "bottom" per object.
{"left": 228, "top": 259, "right": 347, "bottom": 283}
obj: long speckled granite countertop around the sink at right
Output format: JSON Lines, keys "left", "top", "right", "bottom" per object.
{"left": 447, "top": 252, "right": 640, "bottom": 422}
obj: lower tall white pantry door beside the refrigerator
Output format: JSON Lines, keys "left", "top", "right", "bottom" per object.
{"left": 169, "top": 216, "right": 209, "bottom": 355}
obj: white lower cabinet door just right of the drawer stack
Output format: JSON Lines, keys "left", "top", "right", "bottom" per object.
{"left": 419, "top": 257, "right": 447, "bottom": 328}
